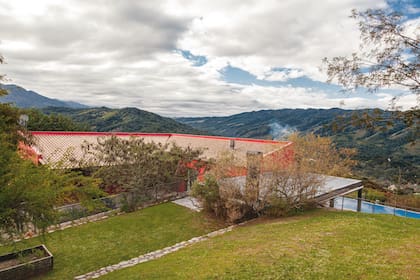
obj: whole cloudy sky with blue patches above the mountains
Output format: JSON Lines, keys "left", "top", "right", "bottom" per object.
{"left": 0, "top": 0, "right": 420, "bottom": 117}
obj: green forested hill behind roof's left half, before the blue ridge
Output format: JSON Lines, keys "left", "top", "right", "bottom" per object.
{"left": 42, "top": 107, "right": 202, "bottom": 134}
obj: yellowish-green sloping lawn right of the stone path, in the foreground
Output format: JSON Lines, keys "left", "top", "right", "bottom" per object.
{"left": 100, "top": 210, "right": 420, "bottom": 280}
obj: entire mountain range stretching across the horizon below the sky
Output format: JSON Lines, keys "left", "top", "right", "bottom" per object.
{"left": 0, "top": 85, "right": 420, "bottom": 183}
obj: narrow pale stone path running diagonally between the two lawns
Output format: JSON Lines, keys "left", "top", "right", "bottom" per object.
{"left": 74, "top": 225, "right": 235, "bottom": 280}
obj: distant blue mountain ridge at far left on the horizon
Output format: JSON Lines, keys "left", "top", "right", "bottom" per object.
{"left": 0, "top": 84, "right": 89, "bottom": 108}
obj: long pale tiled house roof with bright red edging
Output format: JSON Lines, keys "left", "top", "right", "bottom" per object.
{"left": 26, "top": 131, "right": 293, "bottom": 168}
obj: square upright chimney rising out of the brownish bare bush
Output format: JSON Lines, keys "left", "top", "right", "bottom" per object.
{"left": 245, "top": 151, "right": 263, "bottom": 205}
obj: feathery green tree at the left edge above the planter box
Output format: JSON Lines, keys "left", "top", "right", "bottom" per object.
{"left": 0, "top": 53, "right": 102, "bottom": 244}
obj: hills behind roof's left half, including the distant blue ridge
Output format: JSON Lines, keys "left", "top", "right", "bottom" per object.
{"left": 0, "top": 84, "right": 203, "bottom": 134}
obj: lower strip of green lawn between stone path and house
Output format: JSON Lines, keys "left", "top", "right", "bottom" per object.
{"left": 0, "top": 203, "right": 223, "bottom": 280}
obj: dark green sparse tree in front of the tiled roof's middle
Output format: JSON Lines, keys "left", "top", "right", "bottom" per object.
{"left": 81, "top": 136, "right": 201, "bottom": 211}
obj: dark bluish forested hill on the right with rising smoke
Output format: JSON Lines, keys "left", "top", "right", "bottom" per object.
{"left": 177, "top": 108, "right": 420, "bottom": 183}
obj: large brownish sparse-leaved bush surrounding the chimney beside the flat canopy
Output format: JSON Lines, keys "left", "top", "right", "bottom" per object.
{"left": 192, "top": 134, "right": 355, "bottom": 222}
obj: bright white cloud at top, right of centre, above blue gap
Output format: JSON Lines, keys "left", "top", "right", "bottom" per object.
{"left": 174, "top": 1, "right": 386, "bottom": 80}
